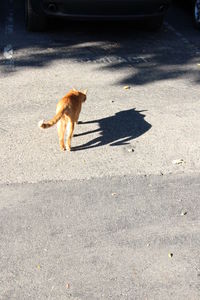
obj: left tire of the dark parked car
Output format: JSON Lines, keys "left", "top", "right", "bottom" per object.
{"left": 25, "top": 0, "right": 47, "bottom": 31}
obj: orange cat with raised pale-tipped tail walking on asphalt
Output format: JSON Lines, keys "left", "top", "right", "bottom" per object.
{"left": 38, "top": 89, "right": 87, "bottom": 151}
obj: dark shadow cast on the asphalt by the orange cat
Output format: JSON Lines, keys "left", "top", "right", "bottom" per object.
{"left": 73, "top": 108, "right": 151, "bottom": 151}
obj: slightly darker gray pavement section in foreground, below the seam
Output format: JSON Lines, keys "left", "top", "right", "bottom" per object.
{"left": 0, "top": 175, "right": 200, "bottom": 299}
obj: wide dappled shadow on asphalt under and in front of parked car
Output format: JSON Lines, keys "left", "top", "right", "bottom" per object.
{"left": 0, "top": 0, "right": 200, "bottom": 85}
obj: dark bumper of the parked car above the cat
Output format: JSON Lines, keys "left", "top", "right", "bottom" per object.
{"left": 32, "top": 0, "right": 170, "bottom": 20}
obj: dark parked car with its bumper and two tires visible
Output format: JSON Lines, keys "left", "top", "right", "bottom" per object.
{"left": 25, "top": 0, "right": 171, "bottom": 31}
